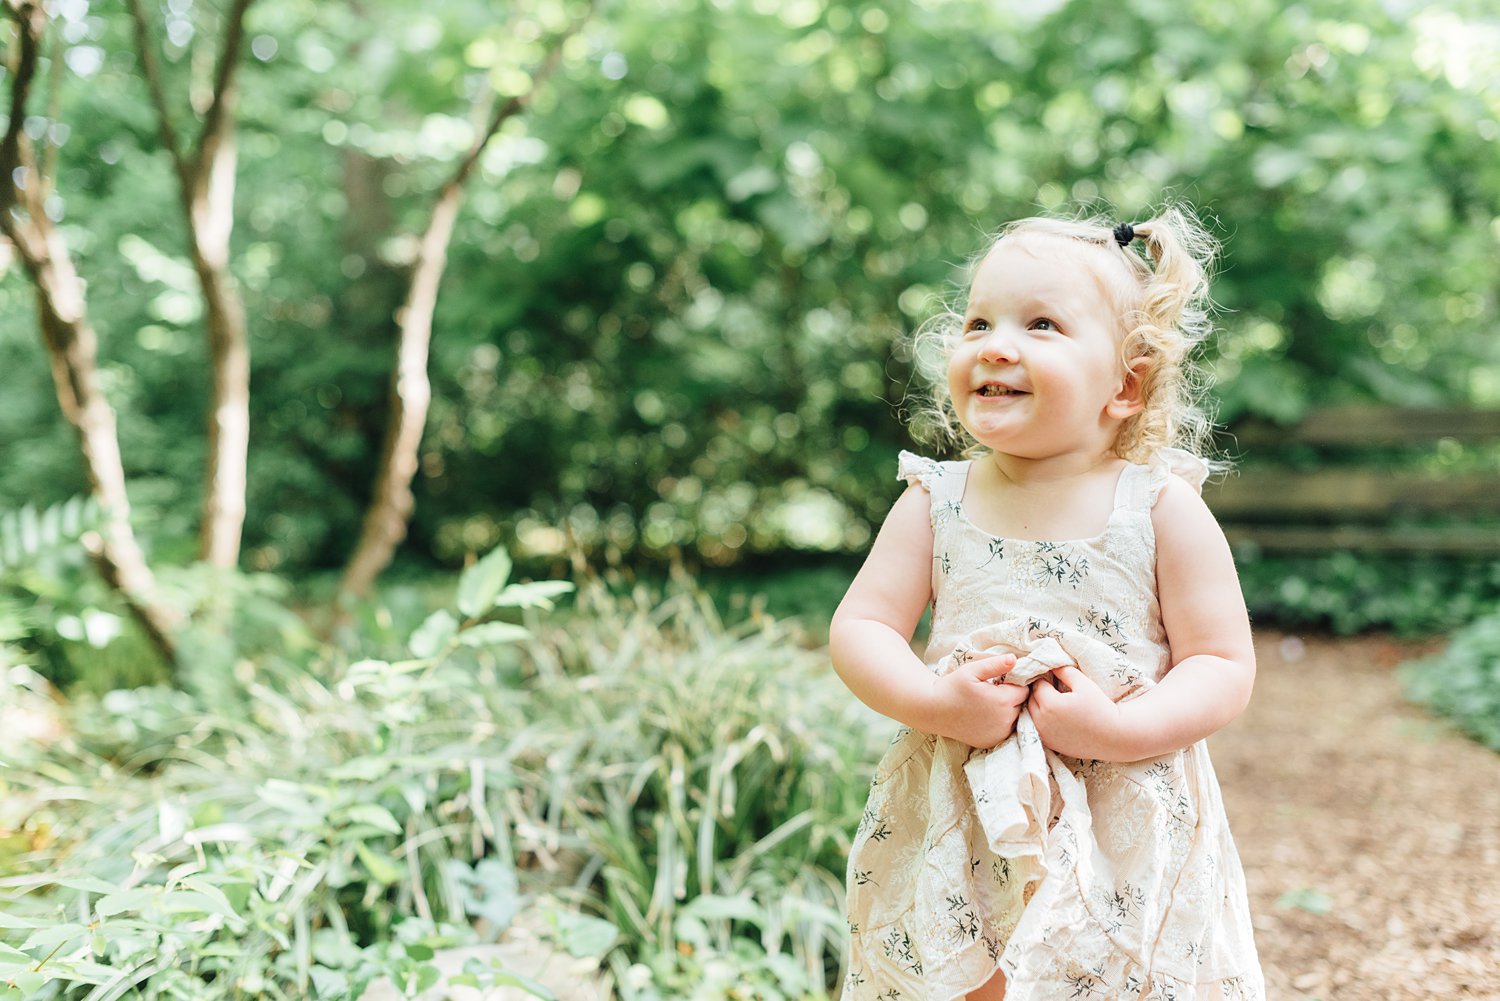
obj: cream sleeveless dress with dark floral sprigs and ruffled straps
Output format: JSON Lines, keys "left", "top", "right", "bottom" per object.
{"left": 843, "top": 452, "right": 1265, "bottom": 1001}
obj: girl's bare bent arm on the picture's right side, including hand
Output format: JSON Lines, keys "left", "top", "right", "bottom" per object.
{"left": 1031, "top": 477, "right": 1256, "bottom": 761}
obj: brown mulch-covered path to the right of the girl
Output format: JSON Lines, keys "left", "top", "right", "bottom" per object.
{"left": 1209, "top": 633, "right": 1500, "bottom": 1001}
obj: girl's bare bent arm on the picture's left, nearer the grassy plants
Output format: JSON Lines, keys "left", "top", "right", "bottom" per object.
{"left": 828, "top": 486, "right": 1026, "bottom": 747}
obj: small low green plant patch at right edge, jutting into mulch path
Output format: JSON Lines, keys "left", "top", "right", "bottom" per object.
{"left": 1401, "top": 609, "right": 1500, "bottom": 750}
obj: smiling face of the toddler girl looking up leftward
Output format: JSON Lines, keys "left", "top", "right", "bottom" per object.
{"left": 948, "top": 234, "right": 1140, "bottom": 459}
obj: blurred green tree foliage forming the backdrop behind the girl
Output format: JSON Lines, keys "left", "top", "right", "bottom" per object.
{"left": 0, "top": 0, "right": 1500, "bottom": 570}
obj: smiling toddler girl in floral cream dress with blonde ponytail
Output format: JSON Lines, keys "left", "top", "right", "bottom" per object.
{"left": 830, "top": 210, "right": 1265, "bottom": 1001}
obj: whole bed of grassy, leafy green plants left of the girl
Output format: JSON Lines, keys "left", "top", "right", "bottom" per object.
{"left": 0, "top": 551, "right": 884, "bottom": 1001}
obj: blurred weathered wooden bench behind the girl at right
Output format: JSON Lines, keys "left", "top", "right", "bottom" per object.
{"left": 1203, "top": 405, "right": 1500, "bottom": 558}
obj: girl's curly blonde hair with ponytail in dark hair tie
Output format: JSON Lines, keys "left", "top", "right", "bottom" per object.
{"left": 912, "top": 206, "right": 1218, "bottom": 462}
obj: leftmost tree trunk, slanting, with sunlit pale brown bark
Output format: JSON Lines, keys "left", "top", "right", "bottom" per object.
{"left": 0, "top": 0, "right": 180, "bottom": 668}
